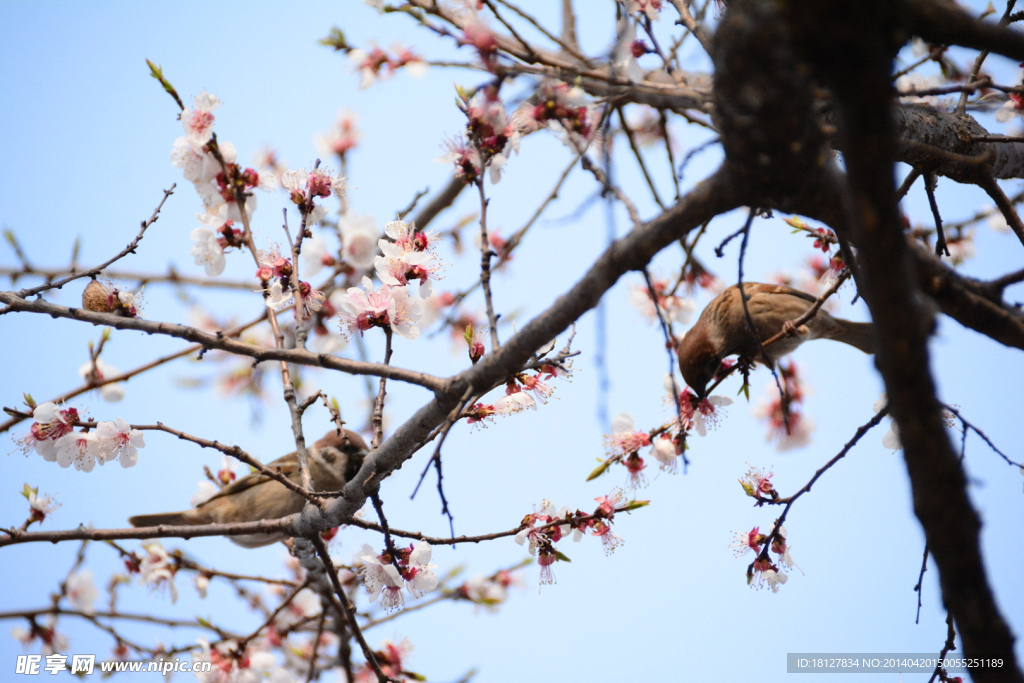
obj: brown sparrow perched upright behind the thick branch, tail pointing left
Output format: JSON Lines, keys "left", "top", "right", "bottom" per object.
{"left": 128, "top": 429, "right": 368, "bottom": 548}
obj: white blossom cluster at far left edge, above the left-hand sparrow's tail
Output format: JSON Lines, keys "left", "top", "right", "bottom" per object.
{"left": 18, "top": 401, "right": 145, "bottom": 472}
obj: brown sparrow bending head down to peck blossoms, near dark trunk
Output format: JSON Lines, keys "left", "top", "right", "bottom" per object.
{"left": 679, "top": 283, "right": 874, "bottom": 396}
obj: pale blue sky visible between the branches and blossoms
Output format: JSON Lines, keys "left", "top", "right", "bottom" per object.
{"left": 0, "top": 0, "right": 1024, "bottom": 682}
